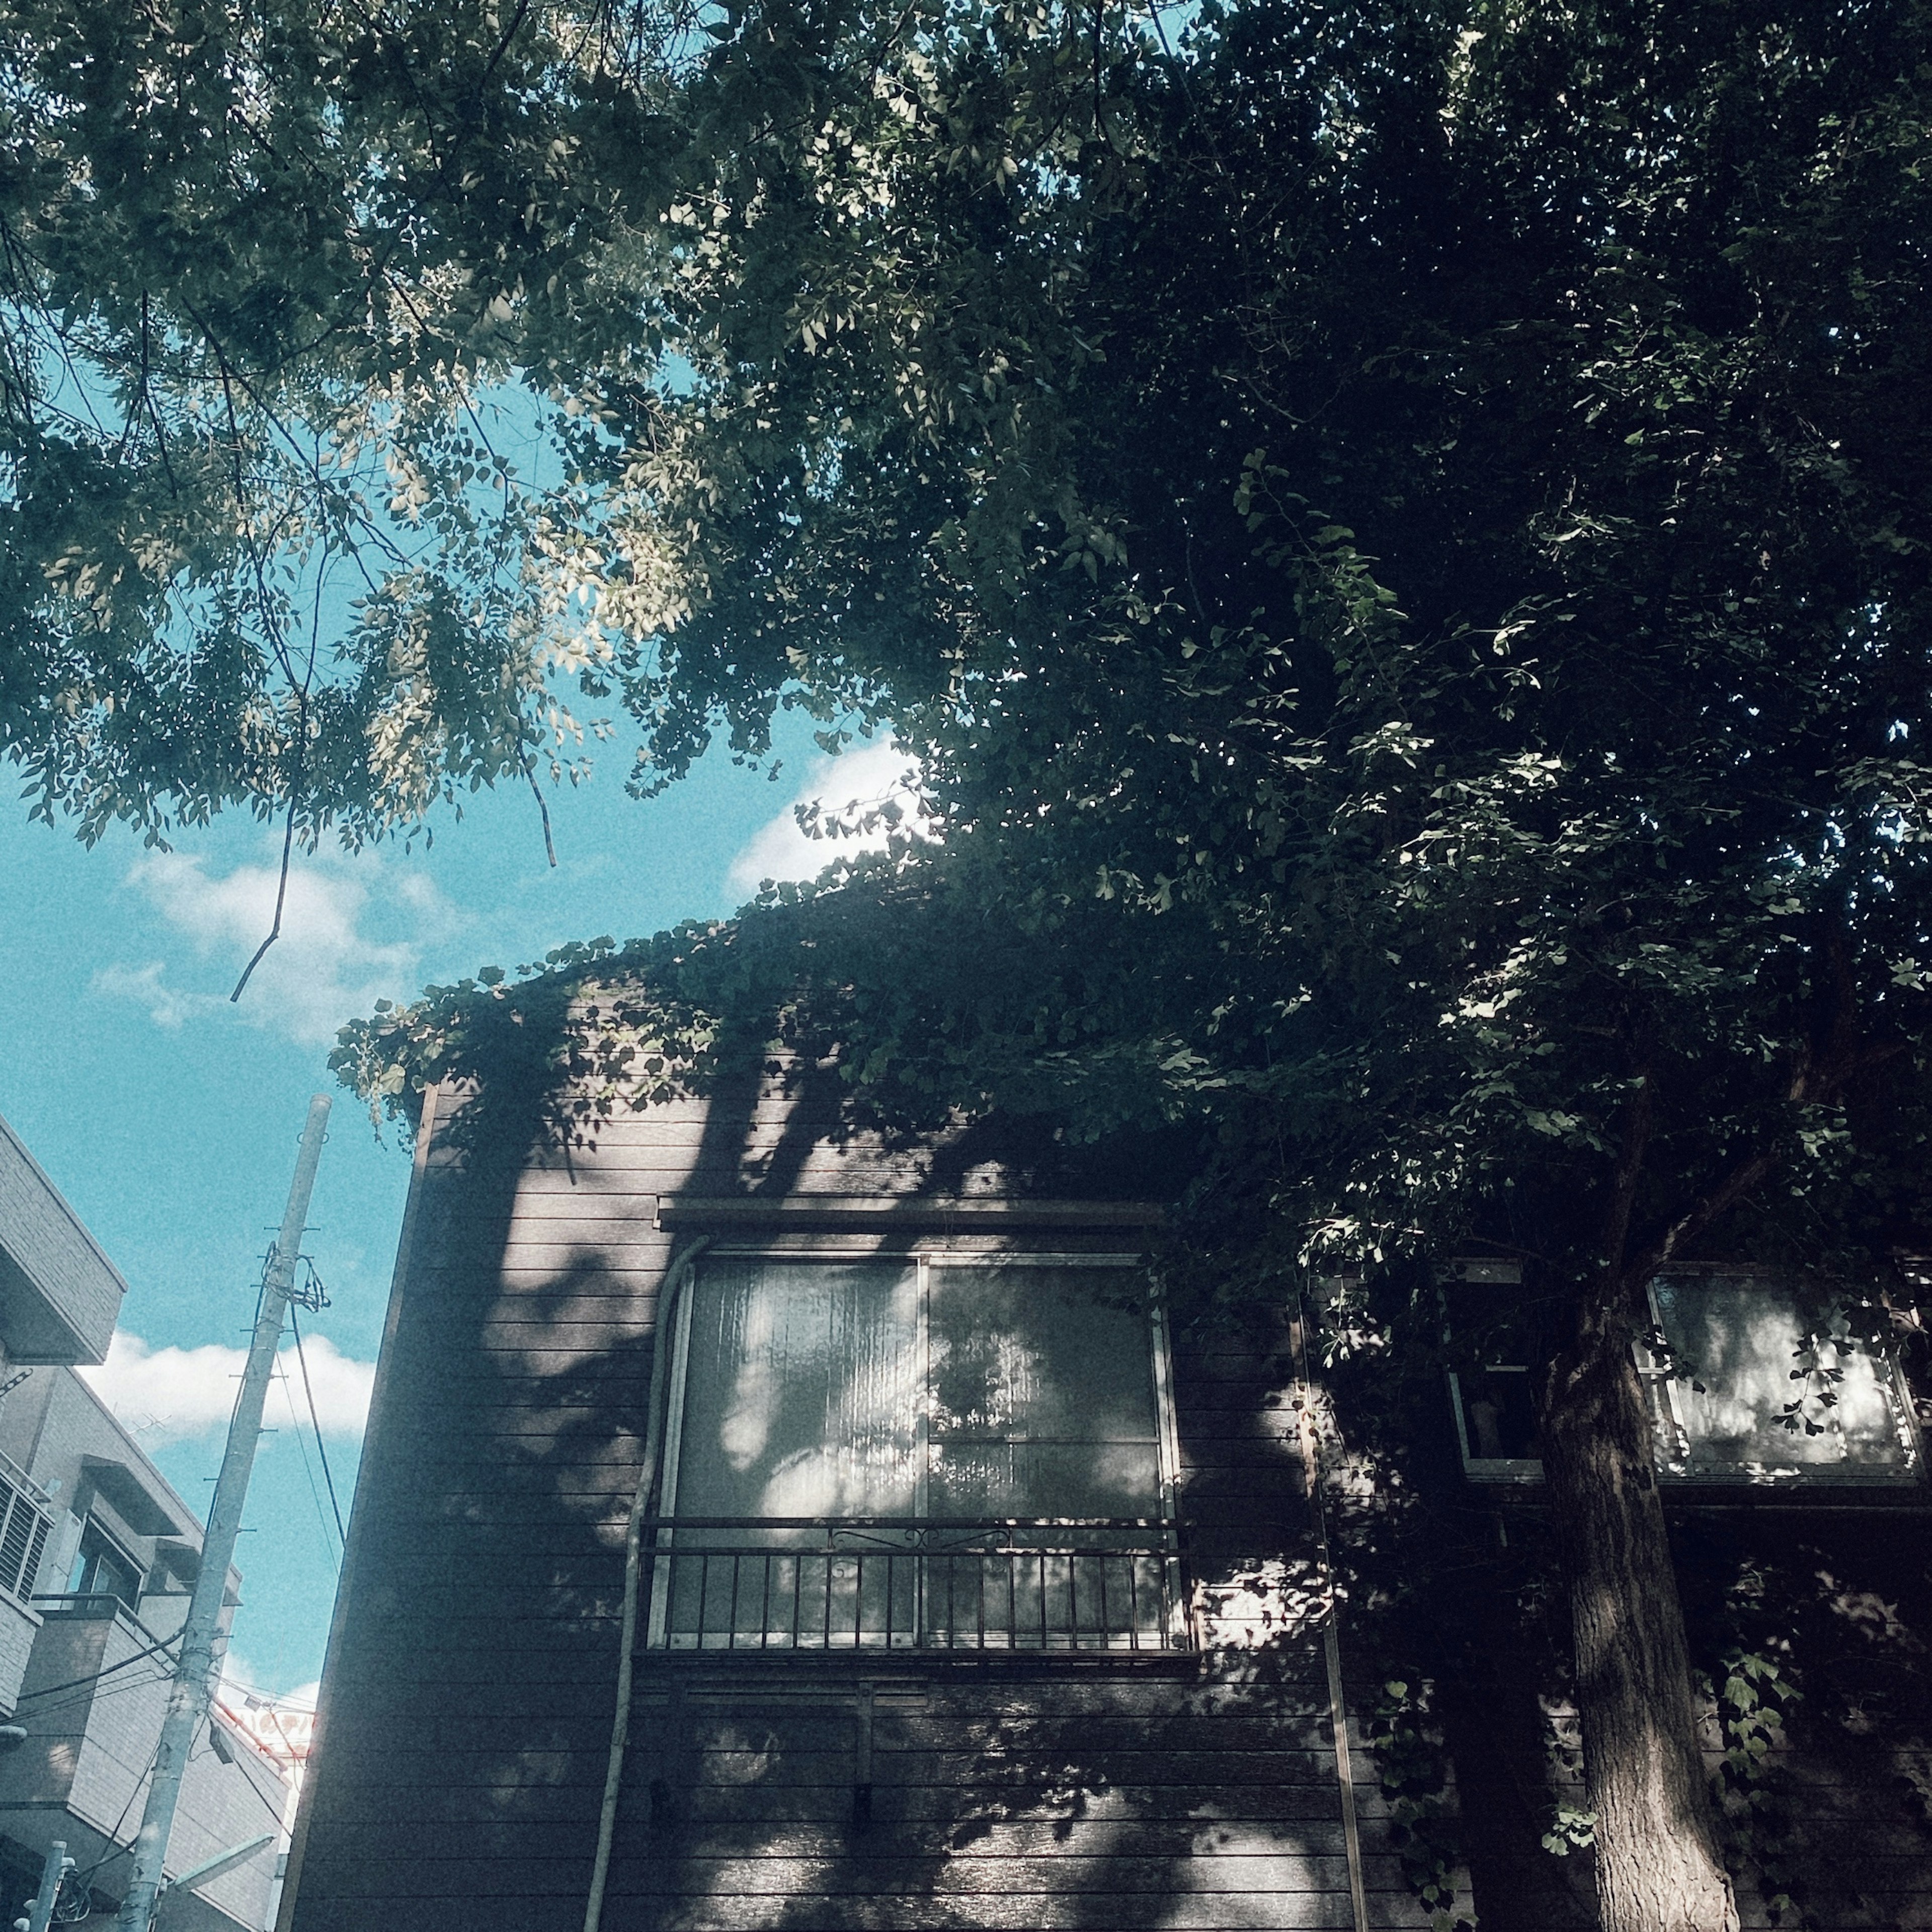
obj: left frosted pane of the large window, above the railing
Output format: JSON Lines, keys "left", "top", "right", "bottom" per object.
{"left": 676, "top": 1260, "right": 920, "bottom": 1540}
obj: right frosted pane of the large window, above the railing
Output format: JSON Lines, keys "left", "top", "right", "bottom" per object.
{"left": 929, "top": 1265, "right": 1159, "bottom": 1516}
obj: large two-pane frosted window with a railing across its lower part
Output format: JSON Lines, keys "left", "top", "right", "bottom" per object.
{"left": 653, "top": 1252, "right": 1178, "bottom": 1648}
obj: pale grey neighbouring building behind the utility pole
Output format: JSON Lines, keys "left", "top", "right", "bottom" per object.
{"left": 0, "top": 1122, "right": 290, "bottom": 1932}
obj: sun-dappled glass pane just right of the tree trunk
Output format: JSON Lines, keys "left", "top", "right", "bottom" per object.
{"left": 1656, "top": 1275, "right": 1907, "bottom": 1474}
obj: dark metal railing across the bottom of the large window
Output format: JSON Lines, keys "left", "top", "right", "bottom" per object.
{"left": 646, "top": 1516, "right": 1190, "bottom": 1652}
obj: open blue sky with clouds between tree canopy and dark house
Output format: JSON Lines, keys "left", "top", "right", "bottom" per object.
{"left": 0, "top": 720, "right": 916, "bottom": 1693}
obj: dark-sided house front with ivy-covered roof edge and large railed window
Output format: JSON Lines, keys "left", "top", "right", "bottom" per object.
{"left": 280, "top": 1063, "right": 1932, "bottom": 1932}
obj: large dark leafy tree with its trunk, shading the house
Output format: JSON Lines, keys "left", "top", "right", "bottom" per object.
{"left": 30, "top": 0, "right": 1932, "bottom": 1932}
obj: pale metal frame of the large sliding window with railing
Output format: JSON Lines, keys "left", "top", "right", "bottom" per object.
{"left": 643, "top": 1235, "right": 1192, "bottom": 1658}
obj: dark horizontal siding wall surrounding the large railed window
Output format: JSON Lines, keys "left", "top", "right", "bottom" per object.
{"left": 282, "top": 1084, "right": 1426, "bottom": 1932}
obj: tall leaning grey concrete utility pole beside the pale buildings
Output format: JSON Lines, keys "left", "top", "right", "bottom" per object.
{"left": 116, "top": 1093, "right": 329, "bottom": 1932}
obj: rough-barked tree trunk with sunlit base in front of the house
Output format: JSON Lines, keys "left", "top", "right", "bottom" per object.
{"left": 1544, "top": 1281, "right": 1737, "bottom": 1932}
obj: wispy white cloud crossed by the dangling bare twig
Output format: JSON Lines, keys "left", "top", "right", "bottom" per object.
{"left": 93, "top": 852, "right": 450, "bottom": 1045}
